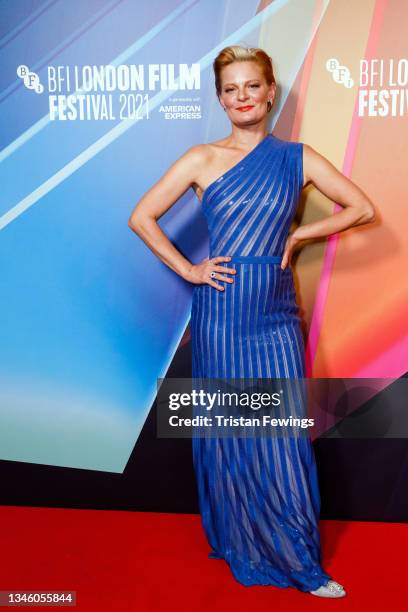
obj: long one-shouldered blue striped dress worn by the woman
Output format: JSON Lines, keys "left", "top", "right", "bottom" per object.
{"left": 190, "top": 134, "right": 331, "bottom": 591}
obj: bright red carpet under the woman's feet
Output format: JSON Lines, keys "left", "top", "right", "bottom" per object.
{"left": 0, "top": 506, "right": 408, "bottom": 612}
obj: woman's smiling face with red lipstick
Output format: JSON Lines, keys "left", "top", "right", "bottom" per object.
{"left": 220, "top": 61, "right": 276, "bottom": 125}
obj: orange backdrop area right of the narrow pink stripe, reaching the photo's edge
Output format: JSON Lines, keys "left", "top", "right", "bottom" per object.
{"left": 313, "top": 0, "right": 408, "bottom": 377}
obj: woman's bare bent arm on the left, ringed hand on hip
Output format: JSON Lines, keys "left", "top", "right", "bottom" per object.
{"left": 128, "top": 145, "right": 235, "bottom": 290}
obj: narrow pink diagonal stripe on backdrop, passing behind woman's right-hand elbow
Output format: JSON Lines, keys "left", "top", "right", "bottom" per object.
{"left": 305, "top": 0, "right": 388, "bottom": 377}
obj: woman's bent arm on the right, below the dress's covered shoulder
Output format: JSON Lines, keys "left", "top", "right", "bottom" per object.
{"left": 281, "top": 144, "right": 375, "bottom": 269}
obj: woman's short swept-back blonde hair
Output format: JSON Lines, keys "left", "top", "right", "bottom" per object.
{"left": 213, "top": 45, "right": 276, "bottom": 97}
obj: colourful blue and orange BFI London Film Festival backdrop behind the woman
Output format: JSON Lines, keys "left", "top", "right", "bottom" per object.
{"left": 0, "top": 0, "right": 408, "bottom": 516}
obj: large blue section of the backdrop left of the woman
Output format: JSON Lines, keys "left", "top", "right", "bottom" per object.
{"left": 0, "top": 0, "right": 318, "bottom": 472}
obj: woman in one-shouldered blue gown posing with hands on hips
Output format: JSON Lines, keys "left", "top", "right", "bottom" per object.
{"left": 129, "top": 46, "right": 374, "bottom": 597}
